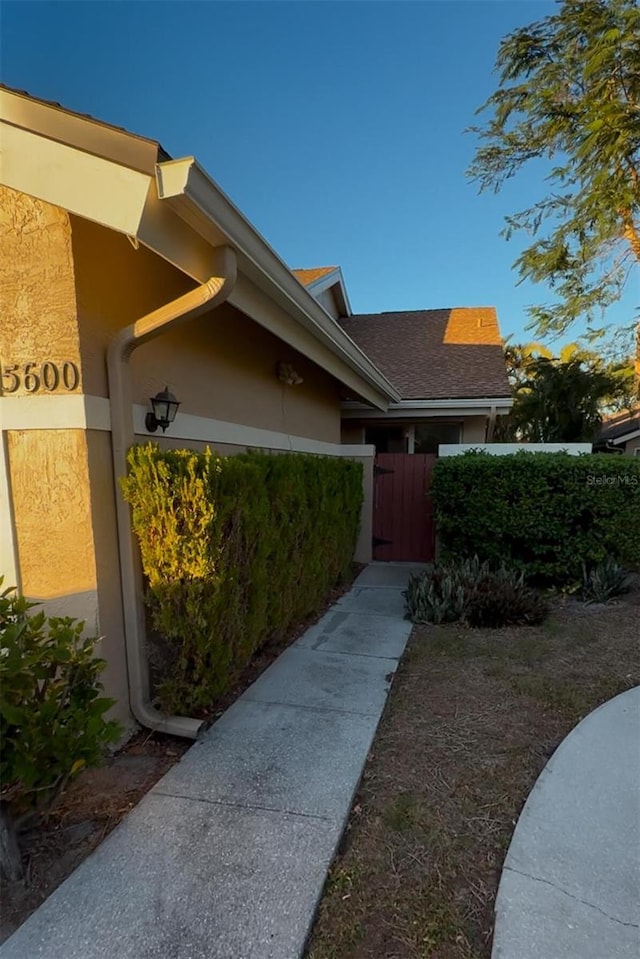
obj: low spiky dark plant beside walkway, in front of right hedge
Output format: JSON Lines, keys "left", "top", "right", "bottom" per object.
{"left": 405, "top": 556, "right": 548, "bottom": 628}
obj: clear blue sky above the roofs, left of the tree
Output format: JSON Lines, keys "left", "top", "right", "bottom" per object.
{"left": 0, "top": 0, "right": 640, "bottom": 341}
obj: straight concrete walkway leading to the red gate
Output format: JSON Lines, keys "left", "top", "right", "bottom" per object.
{"left": 0, "top": 564, "right": 424, "bottom": 959}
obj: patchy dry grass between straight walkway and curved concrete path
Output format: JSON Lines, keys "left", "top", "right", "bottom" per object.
{"left": 307, "top": 588, "right": 640, "bottom": 959}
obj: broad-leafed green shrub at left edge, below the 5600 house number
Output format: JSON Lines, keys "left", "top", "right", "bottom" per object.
{"left": 0, "top": 577, "right": 120, "bottom": 881}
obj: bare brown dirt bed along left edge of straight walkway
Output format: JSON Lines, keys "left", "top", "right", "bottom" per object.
{"left": 0, "top": 564, "right": 363, "bottom": 943}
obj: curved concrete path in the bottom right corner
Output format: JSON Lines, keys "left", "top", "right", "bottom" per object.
{"left": 492, "top": 687, "right": 640, "bottom": 959}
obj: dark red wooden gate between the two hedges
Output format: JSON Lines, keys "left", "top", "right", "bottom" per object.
{"left": 373, "top": 453, "right": 437, "bottom": 563}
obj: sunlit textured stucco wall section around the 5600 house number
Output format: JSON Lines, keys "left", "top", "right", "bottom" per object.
{"left": 0, "top": 188, "right": 128, "bottom": 720}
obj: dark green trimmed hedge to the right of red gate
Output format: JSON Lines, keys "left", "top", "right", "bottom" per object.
{"left": 431, "top": 451, "right": 640, "bottom": 586}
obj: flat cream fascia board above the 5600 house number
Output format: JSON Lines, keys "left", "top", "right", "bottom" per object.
{"left": 0, "top": 123, "right": 154, "bottom": 236}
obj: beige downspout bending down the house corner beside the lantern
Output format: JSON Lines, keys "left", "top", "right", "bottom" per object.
{"left": 107, "top": 247, "right": 237, "bottom": 739}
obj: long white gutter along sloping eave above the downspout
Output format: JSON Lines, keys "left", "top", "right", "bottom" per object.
{"left": 158, "top": 157, "right": 400, "bottom": 408}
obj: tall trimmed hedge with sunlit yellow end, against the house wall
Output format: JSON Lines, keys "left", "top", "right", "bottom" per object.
{"left": 122, "top": 444, "right": 362, "bottom": 711}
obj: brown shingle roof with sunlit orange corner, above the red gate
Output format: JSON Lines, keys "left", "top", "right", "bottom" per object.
{"left": 340, "top": 306, "right": 511, "bottom": 400}
